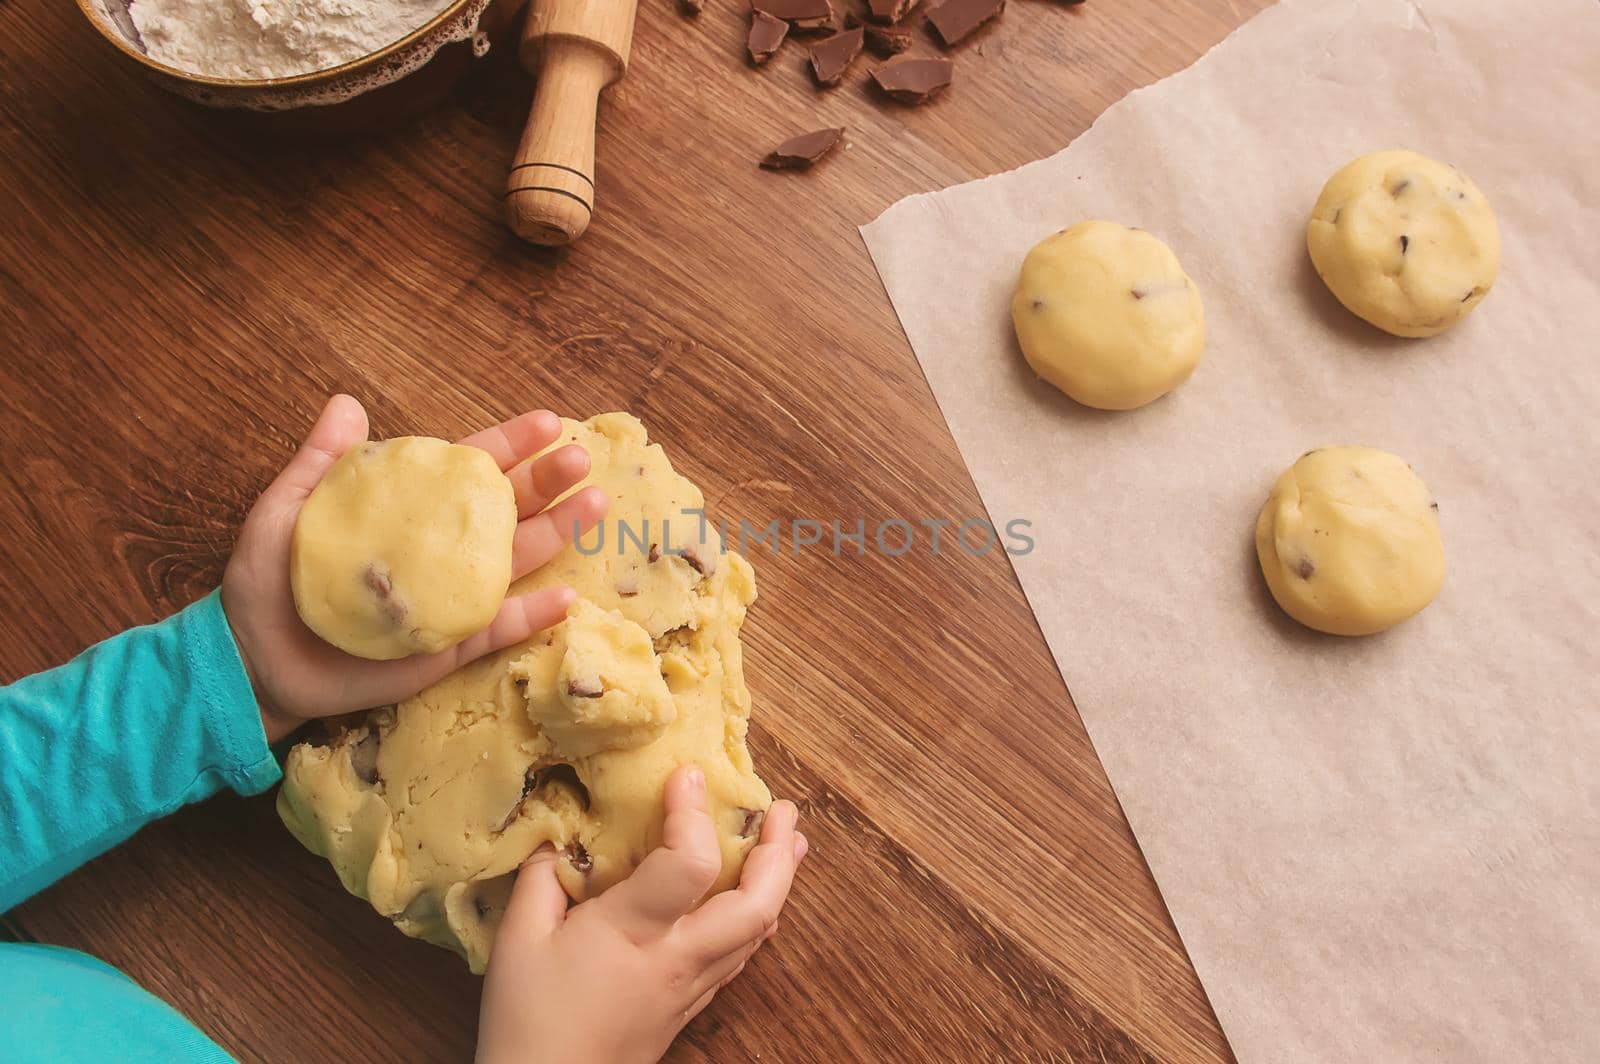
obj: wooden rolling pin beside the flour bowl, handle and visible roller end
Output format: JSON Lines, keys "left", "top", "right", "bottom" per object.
{"left": 506, "top": 0, "right": 638, "bottom": 245}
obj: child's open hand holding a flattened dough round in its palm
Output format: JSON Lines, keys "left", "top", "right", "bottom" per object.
{"left": 222, "top": 395, "right": 608, "bottom": 742}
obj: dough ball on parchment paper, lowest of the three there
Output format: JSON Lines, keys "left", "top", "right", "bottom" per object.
{"left": 1256, "top": 446, "right": 1445, "bottom": 635}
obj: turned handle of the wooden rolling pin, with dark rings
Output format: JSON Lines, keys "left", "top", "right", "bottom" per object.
{"left": 506, "top": 38, "right": 619, "bottom": 246}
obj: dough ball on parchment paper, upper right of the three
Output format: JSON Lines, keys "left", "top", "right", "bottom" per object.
{"left": 1306, "top": 152, "right": 1499, "bottom": 336}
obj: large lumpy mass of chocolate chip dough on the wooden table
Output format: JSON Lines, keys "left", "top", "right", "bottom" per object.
{"left": 278, "top": 413, "right": 771, "bottom": 971}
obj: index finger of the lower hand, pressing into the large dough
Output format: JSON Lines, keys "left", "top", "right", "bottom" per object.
{"left": 600, "top": 765, "right": 722, "bottom": 938}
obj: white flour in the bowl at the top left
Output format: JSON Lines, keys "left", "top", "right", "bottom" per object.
{"left": 128, "top": 0, "right": 450, "bottom": 78}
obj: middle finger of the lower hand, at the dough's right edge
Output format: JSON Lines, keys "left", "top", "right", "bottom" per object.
{"left": 682, "top": 802, "right": 806, "bottom": 957}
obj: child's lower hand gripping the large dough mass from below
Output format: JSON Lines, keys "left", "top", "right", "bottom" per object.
{"left": 477, "top": 765, "right": 806, "bottom": 1064}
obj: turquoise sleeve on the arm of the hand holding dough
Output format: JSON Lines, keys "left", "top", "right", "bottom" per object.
{"left": 0, "top": 592, "right": 280, "bottom": 912}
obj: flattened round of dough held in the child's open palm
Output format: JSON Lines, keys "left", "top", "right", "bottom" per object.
{"left": 290, "top": 437, "right": 517, "bottom": 661}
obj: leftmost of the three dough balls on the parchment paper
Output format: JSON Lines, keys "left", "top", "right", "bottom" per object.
{"left": 1011, "top": 221, "right": 1205, "bottom": 410}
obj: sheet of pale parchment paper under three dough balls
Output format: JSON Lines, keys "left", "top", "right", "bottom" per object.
{"left": 862, "top": 0, "right": 1600, "bottom": 1062}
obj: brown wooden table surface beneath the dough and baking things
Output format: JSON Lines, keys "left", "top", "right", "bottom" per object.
{"left": 0, "top": 0, "right": 1264, "bottom": 1062}
